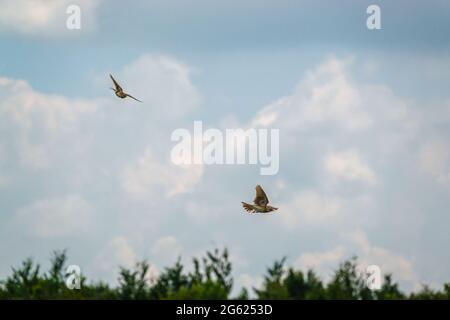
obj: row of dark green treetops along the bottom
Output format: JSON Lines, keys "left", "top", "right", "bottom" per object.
{"left": 0, "top": 249, "right": 450, "bottom": 299}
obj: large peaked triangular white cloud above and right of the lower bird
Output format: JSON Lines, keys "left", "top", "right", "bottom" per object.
{"left": 252, "top": 58, "right": 372, "bottom": 130}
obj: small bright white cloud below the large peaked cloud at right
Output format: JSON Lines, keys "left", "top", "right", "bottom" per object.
{"left": 324, "top": 150, "right": 376, "bottom": 184}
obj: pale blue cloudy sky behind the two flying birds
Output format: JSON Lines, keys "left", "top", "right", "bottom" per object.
{"left": 0, "top": 0, "right": 450, "bottom": 291}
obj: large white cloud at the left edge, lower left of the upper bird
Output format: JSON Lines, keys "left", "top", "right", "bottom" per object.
{"left": 0, "top": 77, "right": 96, "bottom": 168}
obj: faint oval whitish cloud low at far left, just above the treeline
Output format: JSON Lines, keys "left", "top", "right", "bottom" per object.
{"left": 15, "top": 195, "right": 93, "bottom": 238}
